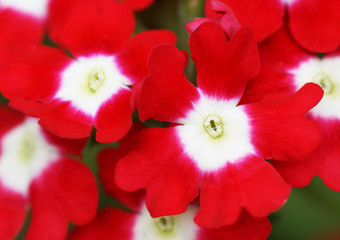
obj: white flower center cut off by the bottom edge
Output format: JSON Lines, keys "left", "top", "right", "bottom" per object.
{"left": 133, "top": 205, "right": 199, "bottom": 240}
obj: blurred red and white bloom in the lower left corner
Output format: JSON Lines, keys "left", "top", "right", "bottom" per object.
{"left": 0, "top": 106, "right": 98, "bottom": 240}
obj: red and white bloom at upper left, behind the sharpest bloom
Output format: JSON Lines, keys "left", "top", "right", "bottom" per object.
{"left": 0, "top": 0, "right": 176, "bottom": 142}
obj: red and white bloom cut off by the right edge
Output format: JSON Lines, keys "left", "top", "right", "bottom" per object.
{"left": 242, "top": 28, "right": 340, "bottom": 191}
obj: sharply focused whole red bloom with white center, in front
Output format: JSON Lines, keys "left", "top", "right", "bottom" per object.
{"left": 116, "top": 22, "right": 322, "bottom": 228}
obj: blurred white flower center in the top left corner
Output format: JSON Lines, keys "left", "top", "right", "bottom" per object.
{"left": 0, "top": 0, "right": 49, "bottom": 18}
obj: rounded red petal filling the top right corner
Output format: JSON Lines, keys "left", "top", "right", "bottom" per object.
{"left": 288, "top": 0, "right": 340, "bottom": 52}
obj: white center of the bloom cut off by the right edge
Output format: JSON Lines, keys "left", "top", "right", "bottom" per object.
{"left": 289, "top": 57, "right": 340, "bottom": 119}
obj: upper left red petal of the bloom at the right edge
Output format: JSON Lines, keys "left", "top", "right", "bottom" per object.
{"left": 240, "top": 27, "right": 315, "bottom": 104}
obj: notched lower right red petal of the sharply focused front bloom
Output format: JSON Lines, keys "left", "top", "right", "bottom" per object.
{"left": 195, "top": 156, "right": 290, "bottom": 228}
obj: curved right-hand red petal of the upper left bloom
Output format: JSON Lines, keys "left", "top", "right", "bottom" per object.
{"left": 117, "top": 30, "right": 177, "bottom": 83}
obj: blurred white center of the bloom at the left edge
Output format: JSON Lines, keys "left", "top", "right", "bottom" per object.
{"left": 0, "top": 118, "right": 59, "bottom": 195}
